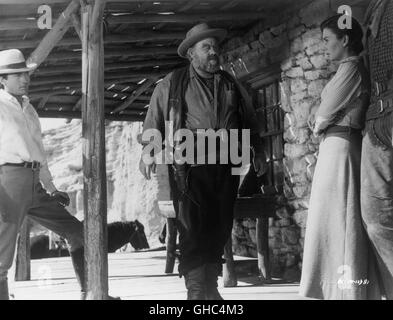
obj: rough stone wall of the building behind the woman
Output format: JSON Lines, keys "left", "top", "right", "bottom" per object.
{"left": 223, "top": 0, "right": 364, "bottom": 280}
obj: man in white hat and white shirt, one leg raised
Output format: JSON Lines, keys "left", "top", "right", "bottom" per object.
{"left": 0, "top": 49, "right": 115, "bottom": 300}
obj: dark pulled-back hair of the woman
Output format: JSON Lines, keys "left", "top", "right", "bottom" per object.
{"left": 320, "top": 14, "right": 364, "bottom": 55}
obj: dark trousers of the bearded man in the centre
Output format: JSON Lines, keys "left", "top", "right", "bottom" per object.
{"left": 177, "top": 164, "right": 239, "bottom": 275}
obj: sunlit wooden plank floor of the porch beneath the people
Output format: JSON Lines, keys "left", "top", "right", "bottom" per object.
{"left": 10, "top": 251, "right": 302, "bottom": 300}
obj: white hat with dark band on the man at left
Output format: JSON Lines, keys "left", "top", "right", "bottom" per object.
{"left": 0, "top": 49, "right": 37, "bottom": 75}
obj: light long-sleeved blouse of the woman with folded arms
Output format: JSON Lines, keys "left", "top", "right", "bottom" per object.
{"left": 314, "top": 56, "right": 367, "bottom": 133}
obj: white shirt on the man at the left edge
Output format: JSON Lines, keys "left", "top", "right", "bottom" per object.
{"left": 0, "top": 90, "right": 56, "bottom": 193}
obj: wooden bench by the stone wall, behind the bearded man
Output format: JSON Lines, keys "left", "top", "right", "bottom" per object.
{"left": 165, "top": 194, "right": 276, "bottom": 287}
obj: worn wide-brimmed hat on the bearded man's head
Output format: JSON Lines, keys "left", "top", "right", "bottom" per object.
{"left": 177, "top": 23, "right": 227, "bottom": 58}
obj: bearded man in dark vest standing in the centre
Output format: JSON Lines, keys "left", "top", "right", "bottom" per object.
{"left": 139, "top": 23, "right": 266, "bottom": 300}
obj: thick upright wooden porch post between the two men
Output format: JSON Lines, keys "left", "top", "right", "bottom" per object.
{"left": 82, "top": 0, "right": 108, "bottom": 300}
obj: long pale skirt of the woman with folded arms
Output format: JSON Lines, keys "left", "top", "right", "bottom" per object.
{"left": 300, "top": 133, "right": 380, "bottom": 300}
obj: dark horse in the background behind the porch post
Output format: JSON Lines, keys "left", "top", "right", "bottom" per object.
{"left": 30, "top": 220, "right": 149, "bottom": 259}
